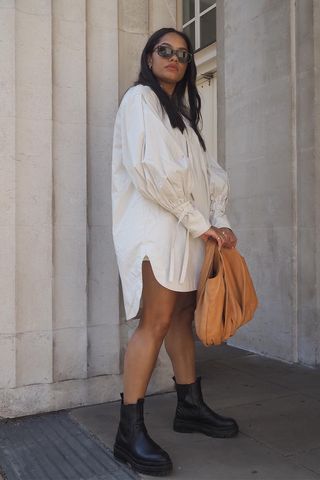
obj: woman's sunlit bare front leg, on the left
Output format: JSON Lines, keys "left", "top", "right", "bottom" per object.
{"left": 123, "top": 262, "right": 178, "bottom": 404}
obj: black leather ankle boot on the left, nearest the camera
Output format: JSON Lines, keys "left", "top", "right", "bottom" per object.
{"left": 113, "top": 394, "right": 172, "bottom": 476}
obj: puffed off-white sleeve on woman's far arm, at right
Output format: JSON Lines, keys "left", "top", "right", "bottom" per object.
{"left": 208, "top": 155, "right": 231, "bottom": 228}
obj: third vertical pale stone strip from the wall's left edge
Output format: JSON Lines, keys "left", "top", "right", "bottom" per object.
{"left": 52, "top": 0, "right": 87, "bottom": 381}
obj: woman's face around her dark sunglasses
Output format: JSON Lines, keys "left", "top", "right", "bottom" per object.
{"left": 148, "top": 33, "right": 188, "bottom": 95}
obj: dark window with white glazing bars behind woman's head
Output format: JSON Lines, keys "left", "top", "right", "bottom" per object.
{"left": 182, "top": 0, "right": 216, "bottom": 50}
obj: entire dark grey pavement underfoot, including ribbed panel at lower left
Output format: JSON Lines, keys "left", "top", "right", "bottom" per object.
{"left": 0, "top": 344, "right": 320, "bottom": 480}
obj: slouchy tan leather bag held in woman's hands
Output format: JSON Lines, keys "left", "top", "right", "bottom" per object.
{"left": 195, "top": 238, "right": 258, "bottom": 346}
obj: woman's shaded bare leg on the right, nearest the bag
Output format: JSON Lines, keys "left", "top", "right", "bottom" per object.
{"left": 165, "top": 291, "right": 196, "bottom": 384}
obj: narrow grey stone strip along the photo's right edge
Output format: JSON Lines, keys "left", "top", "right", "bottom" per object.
{"left": 295, "top": 1, "right": 320, "bottom": 365}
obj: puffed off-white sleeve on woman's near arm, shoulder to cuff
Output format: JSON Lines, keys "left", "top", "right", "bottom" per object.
{"left": 119, "top": 87, "right": 210, "bottom": 238}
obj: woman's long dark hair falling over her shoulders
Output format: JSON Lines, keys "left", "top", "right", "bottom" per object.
{"left": 135, "top": 28, "right": 206, "bottom": 150}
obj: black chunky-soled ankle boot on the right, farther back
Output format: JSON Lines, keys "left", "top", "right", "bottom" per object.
{"left": 173, "top": 377, "right": 239, "bottom": 438}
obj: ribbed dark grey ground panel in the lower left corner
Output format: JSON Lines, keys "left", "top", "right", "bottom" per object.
{"left": 0, "top": 411, "right": 138, "bottom": 480}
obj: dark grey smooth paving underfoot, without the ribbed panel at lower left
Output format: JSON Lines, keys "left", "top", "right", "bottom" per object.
{"left": 70, "top": 345, "right": 320, "bottom": 480}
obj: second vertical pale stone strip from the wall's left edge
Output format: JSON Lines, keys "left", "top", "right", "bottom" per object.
{"left": 15, "top": 0, "right": 52, "bottom": 386}
